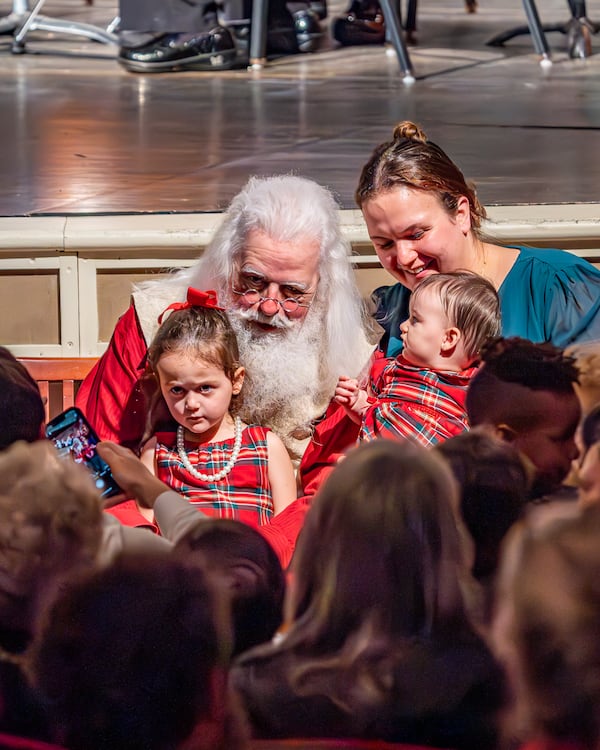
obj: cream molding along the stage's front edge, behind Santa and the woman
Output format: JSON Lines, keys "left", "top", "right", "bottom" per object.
{"left": 0, "top": 203, "right": 600, "bottom": 264}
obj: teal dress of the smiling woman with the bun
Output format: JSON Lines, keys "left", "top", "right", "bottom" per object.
{"left": 373, "top": 245, "right": 600, "bottom": 357}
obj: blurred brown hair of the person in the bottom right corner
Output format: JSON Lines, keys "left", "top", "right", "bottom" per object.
{"left": 494, "top": 505, "right": 600, "bottom": 750}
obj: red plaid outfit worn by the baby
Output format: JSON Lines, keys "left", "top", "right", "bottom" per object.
{"left": 358, "top": 355, "right": 477, "bottom": 446}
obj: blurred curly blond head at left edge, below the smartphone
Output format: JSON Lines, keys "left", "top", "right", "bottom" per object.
{"left": 0, "top": 440, "right": 102, "bottom": 630}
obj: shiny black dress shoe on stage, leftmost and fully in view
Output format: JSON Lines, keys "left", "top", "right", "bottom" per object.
{"left": 117, "top": 26, "right": 237, "bottom": 73}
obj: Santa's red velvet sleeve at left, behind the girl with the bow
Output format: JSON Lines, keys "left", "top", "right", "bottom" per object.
{"left": 75, "top": 304, "right": 146, "bottom": 449}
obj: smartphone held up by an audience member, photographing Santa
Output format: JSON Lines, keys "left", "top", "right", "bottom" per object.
{"left": 46, "top": 406, "right": 122, "bottom": 497}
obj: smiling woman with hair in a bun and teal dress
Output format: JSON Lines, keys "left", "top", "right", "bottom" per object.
{"left": 355, "top": 121, "right": 600, "bottom": 356}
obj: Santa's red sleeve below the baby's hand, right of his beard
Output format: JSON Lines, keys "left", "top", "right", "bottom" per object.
{"left": 300, "top": 401, "right": 360, "bottom": 502}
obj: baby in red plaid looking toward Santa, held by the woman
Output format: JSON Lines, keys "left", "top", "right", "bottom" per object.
{"left": 335, "top": 271, "right": 500, "bottom": 446}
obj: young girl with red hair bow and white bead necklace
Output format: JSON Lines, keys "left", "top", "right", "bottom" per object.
{"left": 141, "top": 289, "right": 296, "bottom": 526}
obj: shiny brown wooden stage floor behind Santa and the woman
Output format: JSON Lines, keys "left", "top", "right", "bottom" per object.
{"left": 0, "top": 0, "right": 600, "bottom": 217}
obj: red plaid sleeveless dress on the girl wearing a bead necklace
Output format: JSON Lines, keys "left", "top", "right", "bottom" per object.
{"left": 155, "top": 425, "right": 273, "bottom": 526}
